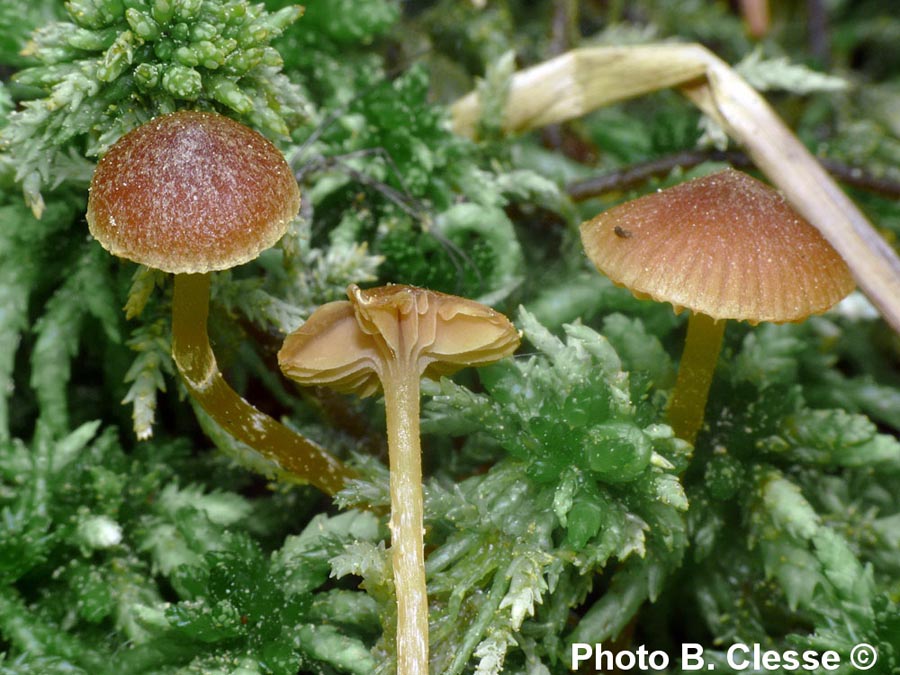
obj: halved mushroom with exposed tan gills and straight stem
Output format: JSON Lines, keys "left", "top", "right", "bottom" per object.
{"left": 278, "top": 285, "right": 519, "bottom": 675}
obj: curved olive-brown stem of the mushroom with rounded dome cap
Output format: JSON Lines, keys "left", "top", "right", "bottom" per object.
{"left": 172, "top": 274, "right": 350, "bottom": 495}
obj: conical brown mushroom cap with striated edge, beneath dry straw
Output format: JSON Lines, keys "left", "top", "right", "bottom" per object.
{"left": 581, "top": 169, "right": 854, "bottom": 324}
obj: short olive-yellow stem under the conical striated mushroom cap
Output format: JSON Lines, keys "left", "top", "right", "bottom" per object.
{"left": 669, "top": 312, "right": 725, "bottom": 443}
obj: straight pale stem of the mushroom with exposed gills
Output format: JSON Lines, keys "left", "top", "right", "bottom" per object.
{"left": 382, "top": 361, "right": 428, "bottom": 675}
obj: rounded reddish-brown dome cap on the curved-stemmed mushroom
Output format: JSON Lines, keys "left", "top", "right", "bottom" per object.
{"left": 87, "top": 111, "right": 300, "bottom": 273}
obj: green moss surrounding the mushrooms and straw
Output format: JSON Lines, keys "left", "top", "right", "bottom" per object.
{"left": 0, "top": 0, "right": 900, "bottom": 675}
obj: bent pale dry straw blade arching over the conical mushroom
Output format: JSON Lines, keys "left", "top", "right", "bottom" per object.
{"left": 452, "top": 44, "right": 900, "bottom": 332}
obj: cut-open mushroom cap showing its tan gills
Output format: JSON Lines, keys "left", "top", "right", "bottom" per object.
{"left": 278, "top": 285, "right": 519, "bottom": 396}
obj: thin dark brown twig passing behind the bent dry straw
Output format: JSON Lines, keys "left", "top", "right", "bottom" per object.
{"left": 566, "top": 150, "right": 900, "bottom": 202}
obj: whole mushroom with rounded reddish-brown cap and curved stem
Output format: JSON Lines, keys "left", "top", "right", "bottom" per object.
{"left": 87, "top": 111, "right": 349, "bottom": 494}
